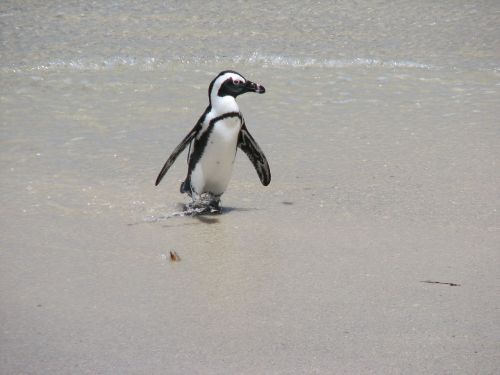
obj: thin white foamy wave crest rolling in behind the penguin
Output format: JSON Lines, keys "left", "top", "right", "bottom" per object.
{"left": 2, "top": 53, "right": 435, "bottom": 73}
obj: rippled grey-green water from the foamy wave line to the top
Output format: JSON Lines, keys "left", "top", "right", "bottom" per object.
{"left": 0, "top": 1, "right": 500, "bottom": 70}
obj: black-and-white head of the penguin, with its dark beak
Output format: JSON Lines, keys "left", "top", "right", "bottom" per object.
{"left": 208, "top": 70, "right": 266, "bottom": 103}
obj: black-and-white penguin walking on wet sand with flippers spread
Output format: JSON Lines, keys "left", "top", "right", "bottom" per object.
{"left": 155, "top": 70, "right": 271, "bottom": 213}
